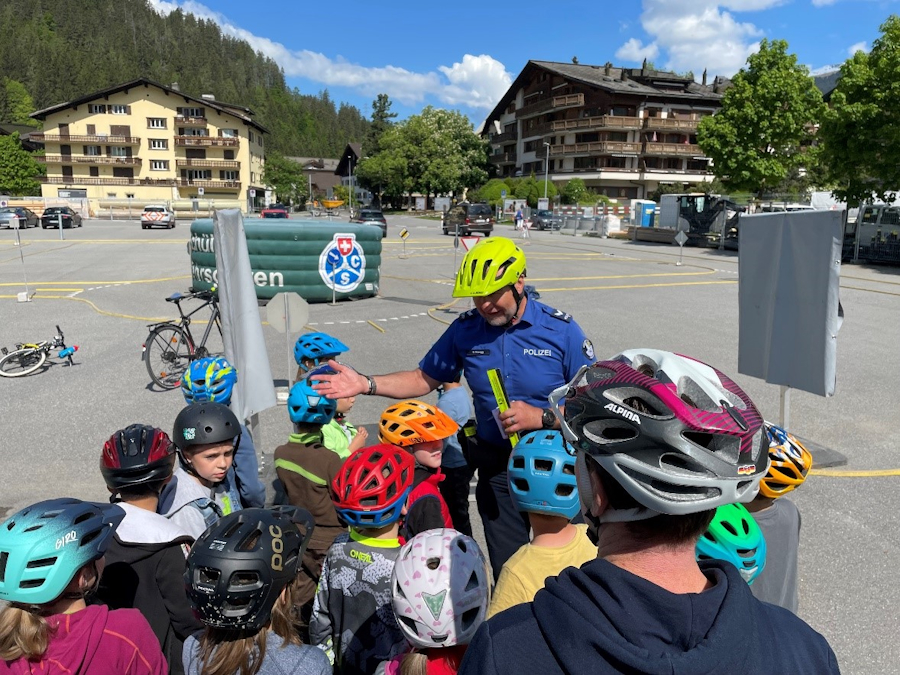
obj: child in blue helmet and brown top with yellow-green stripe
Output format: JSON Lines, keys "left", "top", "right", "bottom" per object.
{"left": 275, "top": 379, "right": 347, "bottom": 640}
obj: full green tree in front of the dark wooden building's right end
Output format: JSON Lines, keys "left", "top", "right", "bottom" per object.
{"left": 697, "top": 40, "right": 824, "bottom": 195}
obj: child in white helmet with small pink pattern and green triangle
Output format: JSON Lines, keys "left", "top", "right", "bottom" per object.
{"left": 384, "top": 529, "right": 491, "bottom": 675}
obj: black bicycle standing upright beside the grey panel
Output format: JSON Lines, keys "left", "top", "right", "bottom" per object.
{"left": 143, "top": 288, "right": 222, "bottom": 389}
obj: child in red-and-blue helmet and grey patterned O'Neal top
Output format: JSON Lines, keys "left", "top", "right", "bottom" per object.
{"left": 309, "top": 444, "right": 415, "bottom": 675}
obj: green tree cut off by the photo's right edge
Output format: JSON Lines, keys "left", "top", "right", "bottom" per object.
{"left": 819, "top": 15, "right": 900, "bottom": 205}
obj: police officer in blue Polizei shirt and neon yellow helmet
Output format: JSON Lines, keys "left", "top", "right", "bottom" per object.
{"left": 315, "top": 237, "right": 594, "bottom": 578}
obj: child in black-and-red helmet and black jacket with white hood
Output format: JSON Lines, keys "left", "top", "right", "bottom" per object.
{"left": 97, "top": 424, "right": 200, "bottom": 675}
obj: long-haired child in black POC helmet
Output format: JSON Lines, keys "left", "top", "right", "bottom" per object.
{"left": 183, "top": 506, "right": 331, "bottom": 675}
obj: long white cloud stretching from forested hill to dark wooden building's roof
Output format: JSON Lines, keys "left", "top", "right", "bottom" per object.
{"left": 150, "top": 0, "right": 512, "bottom": 109}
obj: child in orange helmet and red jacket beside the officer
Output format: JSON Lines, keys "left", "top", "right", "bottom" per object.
{"left": 379, "top": 400, "right": 459, "bottom": 541}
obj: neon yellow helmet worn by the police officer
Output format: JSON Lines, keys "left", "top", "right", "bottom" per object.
{"left": 453, "top": 237, "right": 525, "bottom": 298}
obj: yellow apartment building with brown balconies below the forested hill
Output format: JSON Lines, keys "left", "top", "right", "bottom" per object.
{"left": 31, "top": 78, "right": 267, "bottom": 210}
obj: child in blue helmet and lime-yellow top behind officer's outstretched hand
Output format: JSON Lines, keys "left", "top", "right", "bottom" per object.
{"left": 294, "top": 333, "right": 369, "bottom": 459}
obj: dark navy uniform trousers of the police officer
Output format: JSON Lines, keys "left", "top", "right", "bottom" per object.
{"left": 469, "top": 440, "right": 531, "bottom": 581}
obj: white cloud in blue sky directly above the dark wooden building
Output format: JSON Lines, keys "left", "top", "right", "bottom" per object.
{"left": 616, "top": 0, "right": 787, "bottom": 76}
